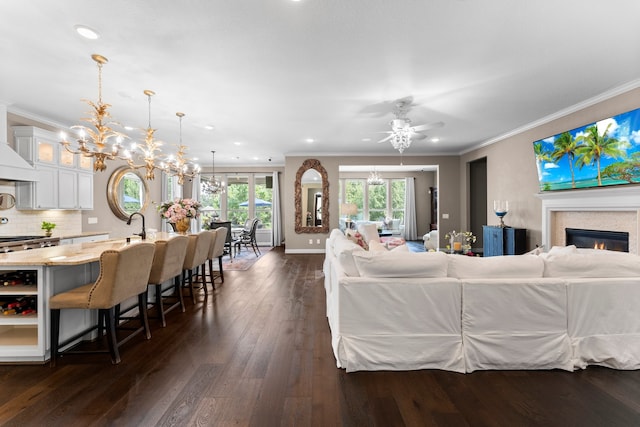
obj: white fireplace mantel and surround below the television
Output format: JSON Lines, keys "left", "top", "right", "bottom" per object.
{"left": 537, "top": 185, "right": 640, "bottom": 254}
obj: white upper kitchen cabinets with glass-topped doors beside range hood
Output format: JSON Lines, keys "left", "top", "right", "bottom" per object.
{"left": 13, "top": 126, "right": 93, "bottom": 210}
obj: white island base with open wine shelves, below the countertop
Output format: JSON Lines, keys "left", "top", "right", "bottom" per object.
{"left": 0, "top": 262, "right": 100, "bottom": 363}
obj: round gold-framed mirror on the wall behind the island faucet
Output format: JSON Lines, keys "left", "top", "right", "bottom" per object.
{"left": 107, "top": 166, "right": 149, "bottom": 221}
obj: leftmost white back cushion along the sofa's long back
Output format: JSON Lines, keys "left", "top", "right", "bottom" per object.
{"left": 353, "top": 251, "right": 447, "bottom": 277}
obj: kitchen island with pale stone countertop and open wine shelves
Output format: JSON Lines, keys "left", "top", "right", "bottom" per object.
{"left": 0, "top": 233, "right": 175, "bottom": 363}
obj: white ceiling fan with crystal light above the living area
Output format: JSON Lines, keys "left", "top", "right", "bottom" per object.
{"left": 378, "top": 96, "right": 444, "bottom": 153}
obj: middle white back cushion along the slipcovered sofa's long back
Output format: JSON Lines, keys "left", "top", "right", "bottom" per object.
{"left": 447, "top": 255, "right": 544, "bottom": 279}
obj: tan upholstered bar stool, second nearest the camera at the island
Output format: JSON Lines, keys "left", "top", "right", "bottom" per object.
{"left": 149, "top": 236, "right": 189, "bottom": 328}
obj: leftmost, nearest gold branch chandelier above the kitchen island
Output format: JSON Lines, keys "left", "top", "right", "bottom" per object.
{"left": 60, "top": 54, "right": 125, "bottom": 171}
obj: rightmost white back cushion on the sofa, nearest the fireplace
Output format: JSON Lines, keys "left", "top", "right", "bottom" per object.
{"left": 540, "top": 251, "right": 640, "bottom": 277}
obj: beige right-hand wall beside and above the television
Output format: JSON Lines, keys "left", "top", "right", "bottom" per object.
{"left": 460, "top": 89, "right": 640, "bottom": 249}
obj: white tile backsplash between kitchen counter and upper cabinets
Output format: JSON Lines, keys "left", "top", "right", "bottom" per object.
{"left": 0, "top": 182, "right": 82, "bottom": 237}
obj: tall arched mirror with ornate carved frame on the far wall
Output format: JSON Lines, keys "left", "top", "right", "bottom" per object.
{"left": 295, "top": 159, "right": 329, "bottom": 233}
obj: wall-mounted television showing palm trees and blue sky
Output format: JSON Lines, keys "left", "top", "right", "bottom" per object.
{"left": 533, "top": 109, "right": 640, "bottom": 191}
